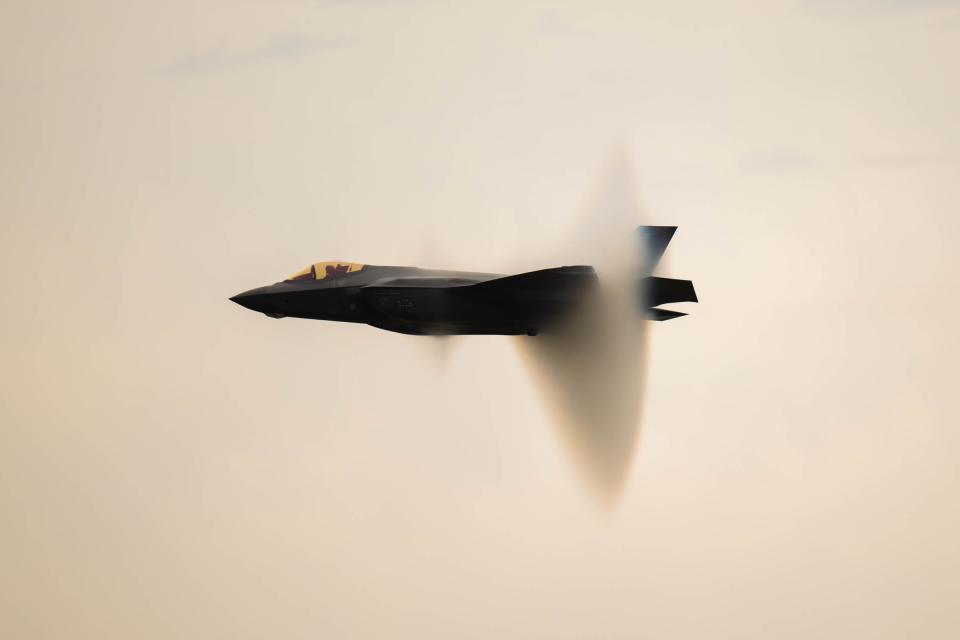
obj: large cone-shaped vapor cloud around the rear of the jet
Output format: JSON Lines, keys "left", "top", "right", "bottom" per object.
{"left": 515, "top": 149, "right": 646, "bottom": 507}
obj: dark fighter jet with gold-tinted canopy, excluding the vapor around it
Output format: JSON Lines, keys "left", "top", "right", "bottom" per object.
{"left": 230, "top": 226, "right": 698, "bottom": 336}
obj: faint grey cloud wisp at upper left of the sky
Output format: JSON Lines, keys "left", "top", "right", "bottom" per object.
{"left": 165, "top": 34, "right": 345, "bottom": 74}
